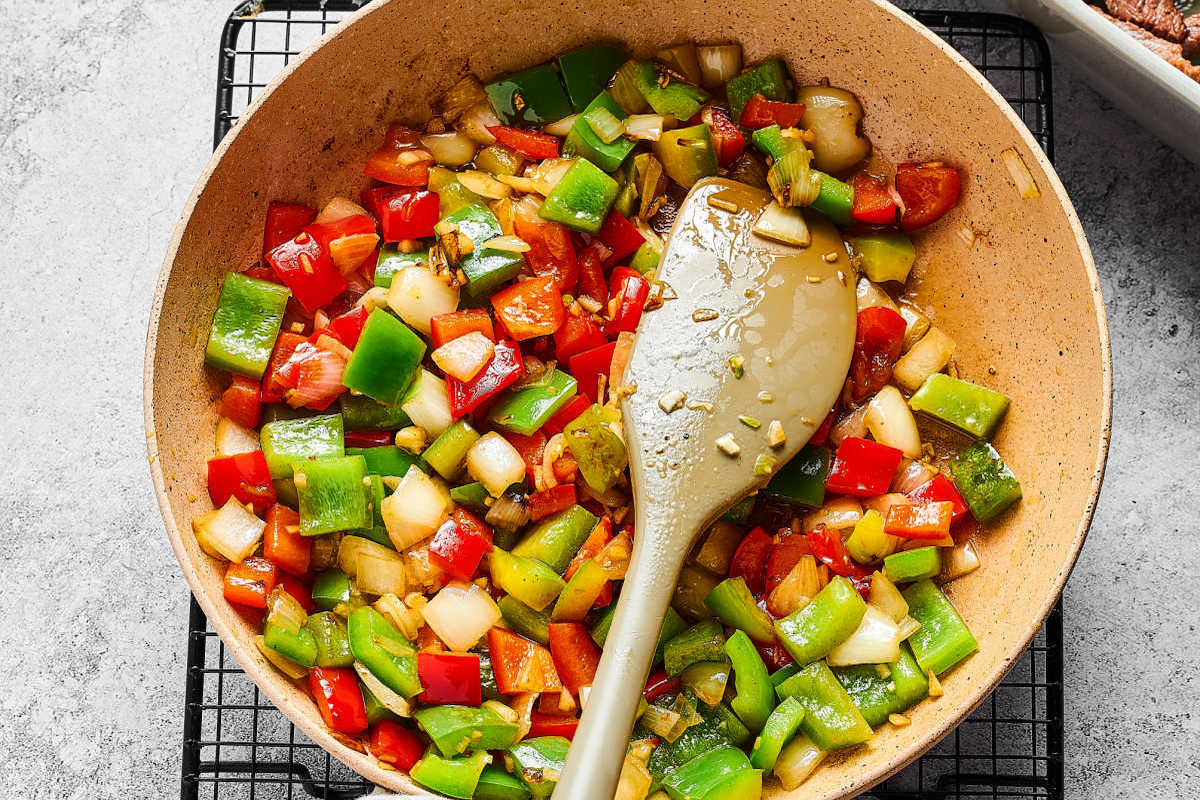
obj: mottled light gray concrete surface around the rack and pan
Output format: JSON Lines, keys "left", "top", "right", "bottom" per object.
{"left": 0, "top": 0, "right": 1200, "bottom": 800}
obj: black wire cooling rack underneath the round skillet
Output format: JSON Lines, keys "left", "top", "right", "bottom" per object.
{"left": 181, "top": 0, "right": 1063, "bottom": 800}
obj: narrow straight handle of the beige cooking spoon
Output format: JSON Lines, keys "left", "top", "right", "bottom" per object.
{"left": 553, "top": 531, "right": 690, "bottom": 800}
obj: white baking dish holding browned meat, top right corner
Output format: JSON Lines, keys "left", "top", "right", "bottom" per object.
{"left": 1008, "top": 0, "right": 1200, "bottom": 164}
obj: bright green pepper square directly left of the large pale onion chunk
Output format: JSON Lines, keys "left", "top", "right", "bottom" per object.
{"left": 294, "top": 456, "right": 372, "bottom": 536}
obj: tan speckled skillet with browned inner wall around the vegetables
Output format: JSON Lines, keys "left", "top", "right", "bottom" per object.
{"left": 145, "top": 0, "right": 1111, "bottom": 800}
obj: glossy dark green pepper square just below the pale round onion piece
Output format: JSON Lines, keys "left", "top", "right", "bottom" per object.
{"left": 342, "top": 308, "right": 425, "bottom": 405}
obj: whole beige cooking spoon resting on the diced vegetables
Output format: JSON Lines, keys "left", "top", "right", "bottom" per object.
{"left": 554, "top": 179, "right": 856, "bottom": 800}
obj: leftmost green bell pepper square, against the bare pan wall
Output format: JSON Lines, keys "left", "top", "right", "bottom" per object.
{"left": 204, "top": 272, "right": 292, "bottom": 380}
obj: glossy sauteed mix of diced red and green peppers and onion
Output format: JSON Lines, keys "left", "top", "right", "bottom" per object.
{"left": 193, "top": 38, "right": 1021, "bottom": 800}
